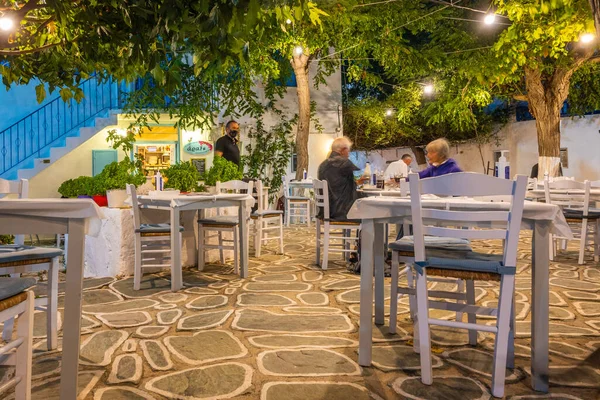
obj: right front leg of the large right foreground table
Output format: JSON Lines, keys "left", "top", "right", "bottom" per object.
{"left": 531, "top": 221, "right": 550, "bottom": 392}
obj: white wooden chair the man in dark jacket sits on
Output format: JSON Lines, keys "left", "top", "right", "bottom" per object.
{"left": 313, "top": 179, "right": 361, "bottom": 270}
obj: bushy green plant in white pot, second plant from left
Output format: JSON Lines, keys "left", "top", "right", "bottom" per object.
{"left": 94, "top": 158, "right": 146, "bottom": 208}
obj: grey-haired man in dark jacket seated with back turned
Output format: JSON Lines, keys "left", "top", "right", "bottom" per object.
{"left": 318, "top": 137, "right": 368, "bottom": 220}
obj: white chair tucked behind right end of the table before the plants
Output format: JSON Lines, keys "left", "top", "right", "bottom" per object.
{"left": 198, "top": 181, "right": 254, "bottom": 274}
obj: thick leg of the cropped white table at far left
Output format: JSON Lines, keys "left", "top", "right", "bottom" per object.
{"left": 60, "top": 219, "right": 85, "bottom": 400}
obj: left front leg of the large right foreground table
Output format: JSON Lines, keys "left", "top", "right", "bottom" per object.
{"left": 358, "top": 219, "right": 375, "bottom": 367}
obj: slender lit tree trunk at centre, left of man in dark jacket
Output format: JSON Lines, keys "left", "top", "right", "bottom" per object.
{"left": 291, "top": 50, "right": 310, "bottom": 179}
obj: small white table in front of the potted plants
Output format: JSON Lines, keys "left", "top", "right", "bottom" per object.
{"left": 138, "top": 193, "right": 254, "bottom": 292}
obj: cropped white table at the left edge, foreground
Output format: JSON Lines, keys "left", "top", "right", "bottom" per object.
{"left": 0, "top": 199, "right": 103, "bottom": 400}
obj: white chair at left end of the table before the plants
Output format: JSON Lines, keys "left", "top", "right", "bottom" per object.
{"left": 127, "top": 185, "right": 183, "bottom": 290}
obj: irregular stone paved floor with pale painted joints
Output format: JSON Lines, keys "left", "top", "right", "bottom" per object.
{"left": 4, "top": 228, "right": 600, "bottom": 400}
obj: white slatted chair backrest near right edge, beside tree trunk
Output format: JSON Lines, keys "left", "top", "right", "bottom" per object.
{"left": 544, "top": 180, "right": 591, "bottom": 215}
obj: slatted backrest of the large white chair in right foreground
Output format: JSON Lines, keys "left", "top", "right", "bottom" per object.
{"left": 410, "top": 172, "right": 527, "bottom": 267}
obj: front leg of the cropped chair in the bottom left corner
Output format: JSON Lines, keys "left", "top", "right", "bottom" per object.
{"left": 15, "top": 292, "right": 35, "bottom": 400}
